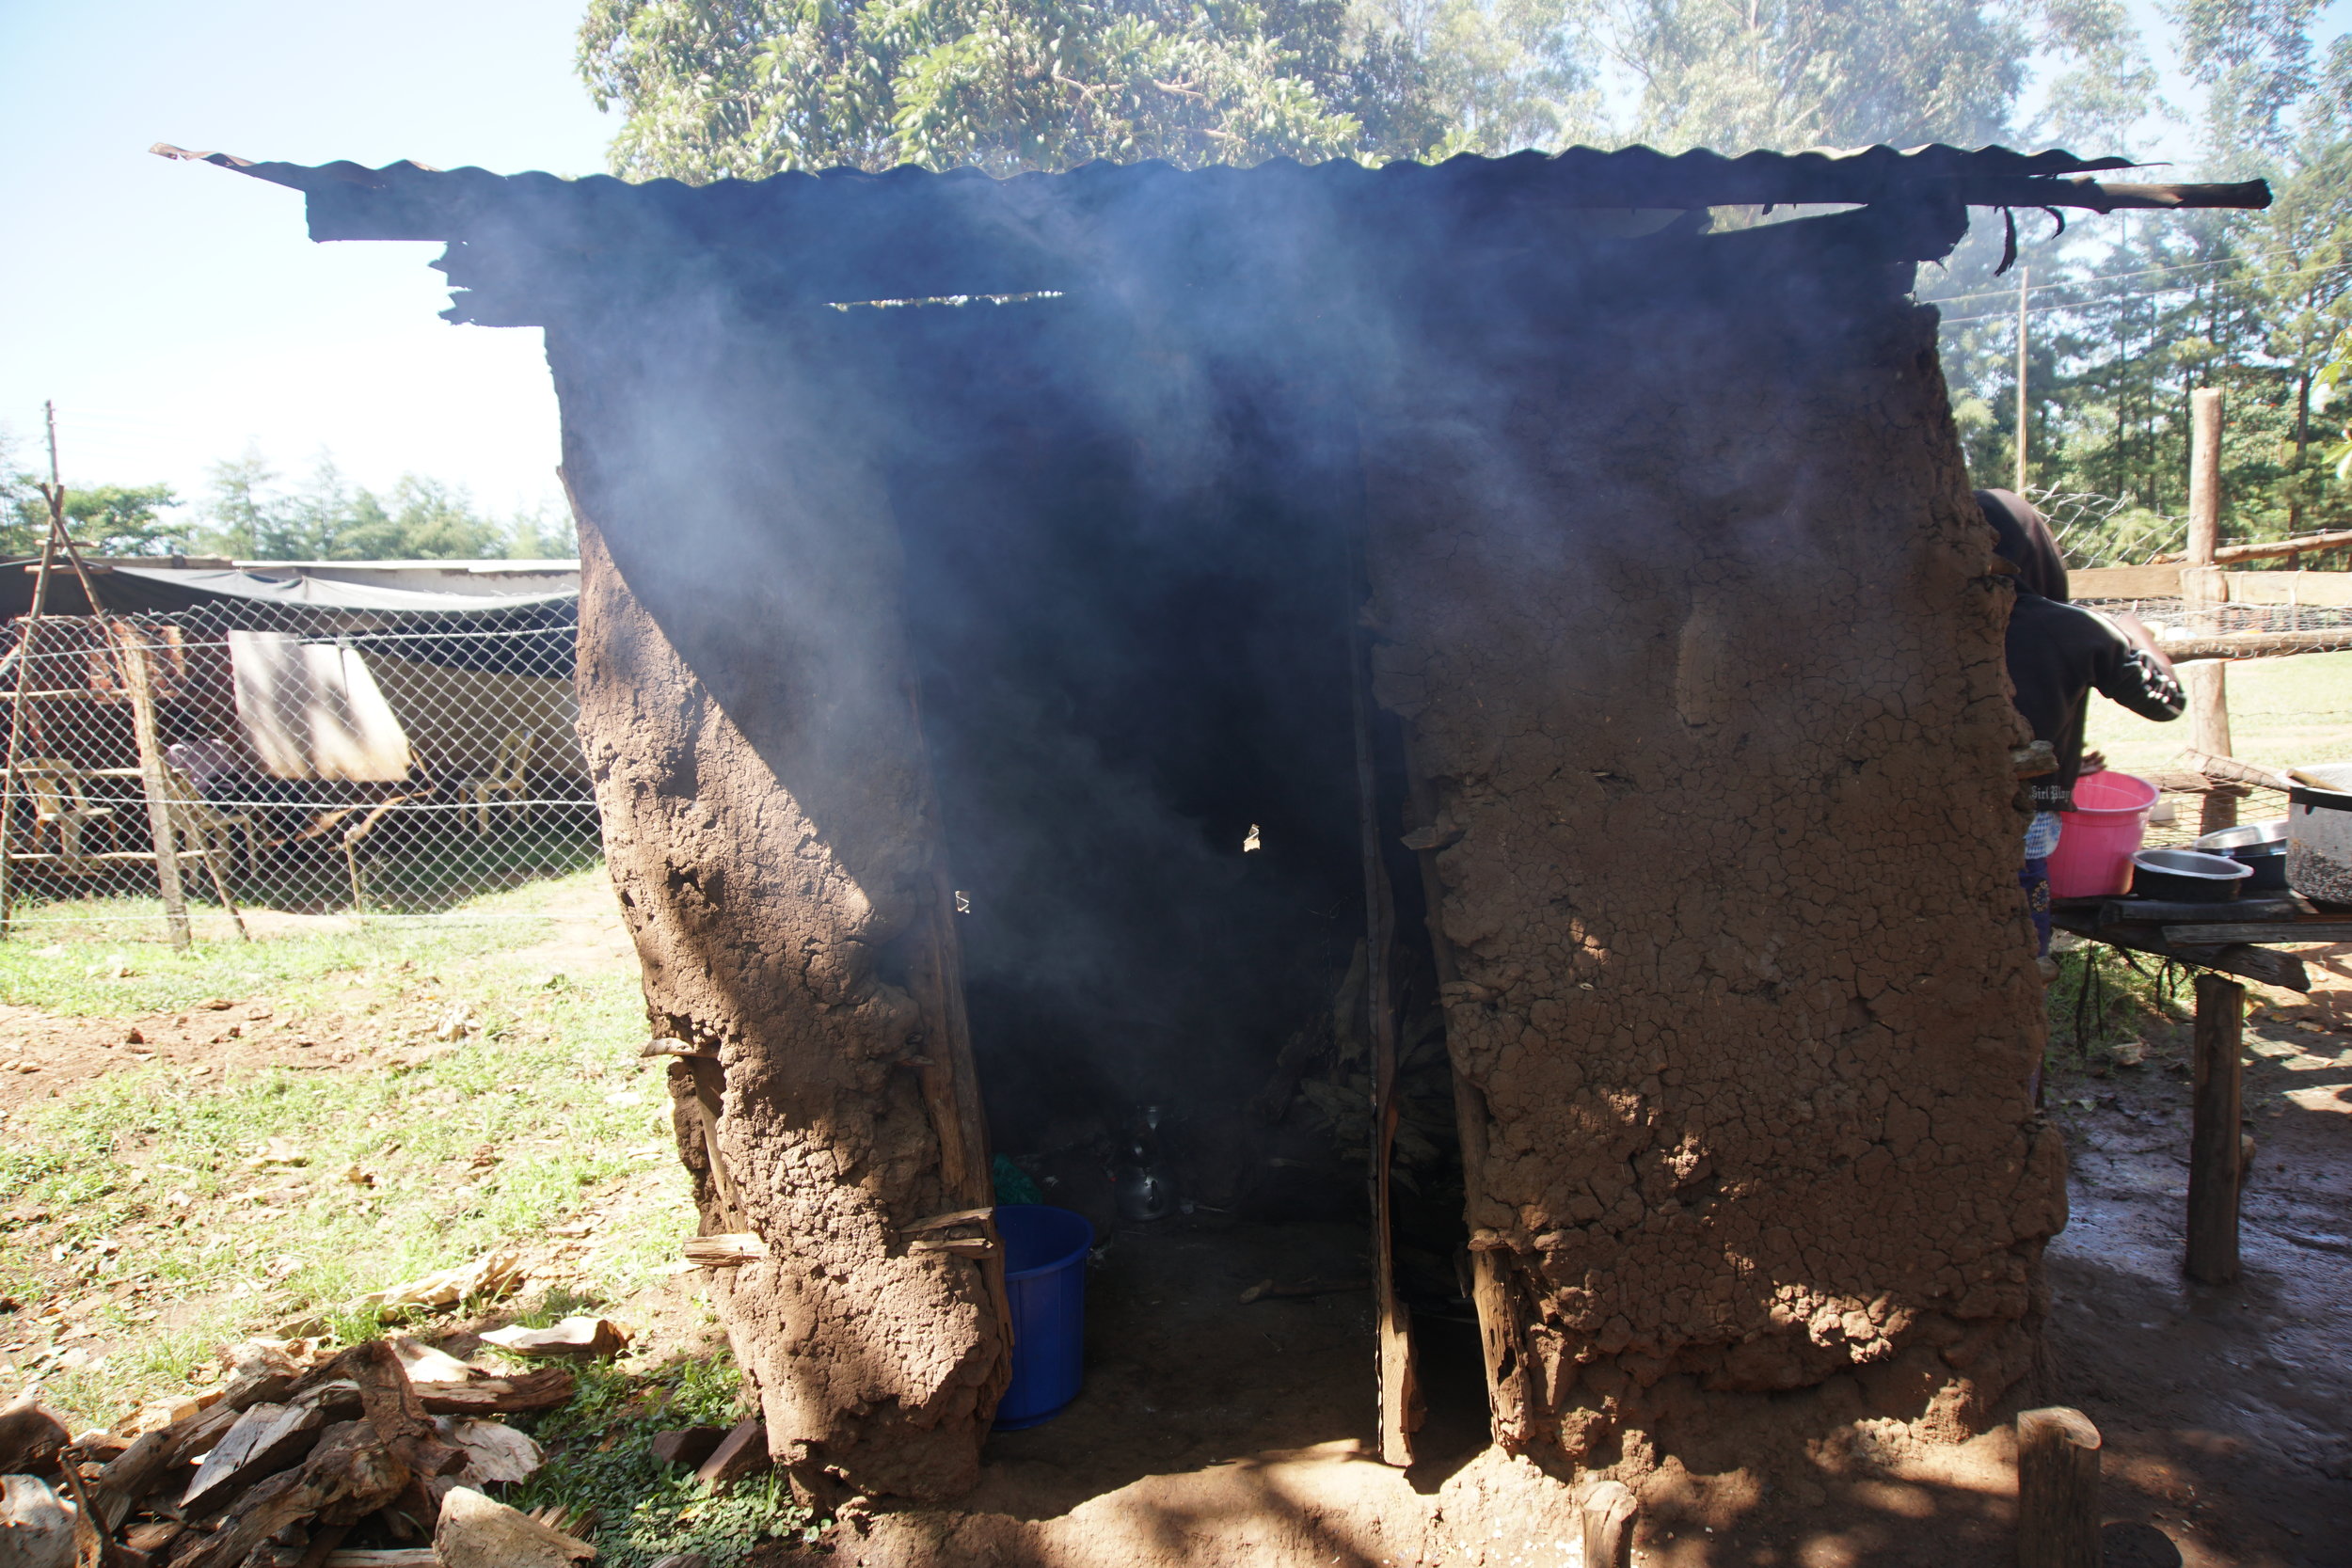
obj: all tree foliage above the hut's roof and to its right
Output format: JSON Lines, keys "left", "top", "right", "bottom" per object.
{"left": 579, "top": 0, "right": 2352, "bottom": 538}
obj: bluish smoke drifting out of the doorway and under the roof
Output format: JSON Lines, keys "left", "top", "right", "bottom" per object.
{"left": 529, "top": 165, "right": 1966, "bottom": 1170}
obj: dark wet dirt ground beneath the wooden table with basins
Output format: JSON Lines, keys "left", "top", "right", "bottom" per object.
{"left": 2049, "top": 950, "right": 2352, "bottom": 1568}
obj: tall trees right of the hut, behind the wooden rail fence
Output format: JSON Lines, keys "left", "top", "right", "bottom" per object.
{"left": 1922, "top": 0, "right": 2352, "bottom": 560}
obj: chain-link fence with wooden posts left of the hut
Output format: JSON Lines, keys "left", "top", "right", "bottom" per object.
{"left": 0, "top": 585, "right": 600, "bottom": 928}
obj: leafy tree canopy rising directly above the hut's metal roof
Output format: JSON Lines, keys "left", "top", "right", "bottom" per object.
{"left": 579, "top": 0, "right": 2154, "bottom": 181}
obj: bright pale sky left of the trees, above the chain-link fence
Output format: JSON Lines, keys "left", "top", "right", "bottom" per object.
{"left": 0, "top": 0, "right": 612, "bottom": 526}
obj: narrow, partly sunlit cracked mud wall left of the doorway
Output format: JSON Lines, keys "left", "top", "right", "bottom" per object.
{"left": 548, "top": 312, "right": 1009, "bottom": 1497}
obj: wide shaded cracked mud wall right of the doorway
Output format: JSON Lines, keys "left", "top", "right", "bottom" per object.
{"left": 1364, "top": 247, "right": 2065, "bottom": 1479}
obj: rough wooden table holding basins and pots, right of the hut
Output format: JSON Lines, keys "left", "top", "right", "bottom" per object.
{"left": 2051, "top": 898, "right": 2352, "bottom": 1286}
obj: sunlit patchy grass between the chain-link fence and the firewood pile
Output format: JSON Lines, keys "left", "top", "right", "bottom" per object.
{"left": 0, "top": 869, "right": 691, "bottom": 1425}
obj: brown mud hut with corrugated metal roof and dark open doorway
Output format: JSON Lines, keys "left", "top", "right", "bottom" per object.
{"left": 174, "top": 146, "right": 2267, "bottom": 1500}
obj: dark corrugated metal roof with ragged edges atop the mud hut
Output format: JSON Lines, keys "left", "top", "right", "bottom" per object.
{"left": 155, "top": 146, "right": 2270, "bottom": 325}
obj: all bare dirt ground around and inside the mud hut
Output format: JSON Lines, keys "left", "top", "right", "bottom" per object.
{"left": 0, "top": 917, "right": 2352, "bottom": 1568}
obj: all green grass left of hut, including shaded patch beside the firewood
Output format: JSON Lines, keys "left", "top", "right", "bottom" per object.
{"left": 0, "top": 867, "right": 818, "bottom": 1568}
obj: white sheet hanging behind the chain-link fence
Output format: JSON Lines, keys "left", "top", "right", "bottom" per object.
{"left": 229, "top": 632, "right": 412, "bottom": 783}
